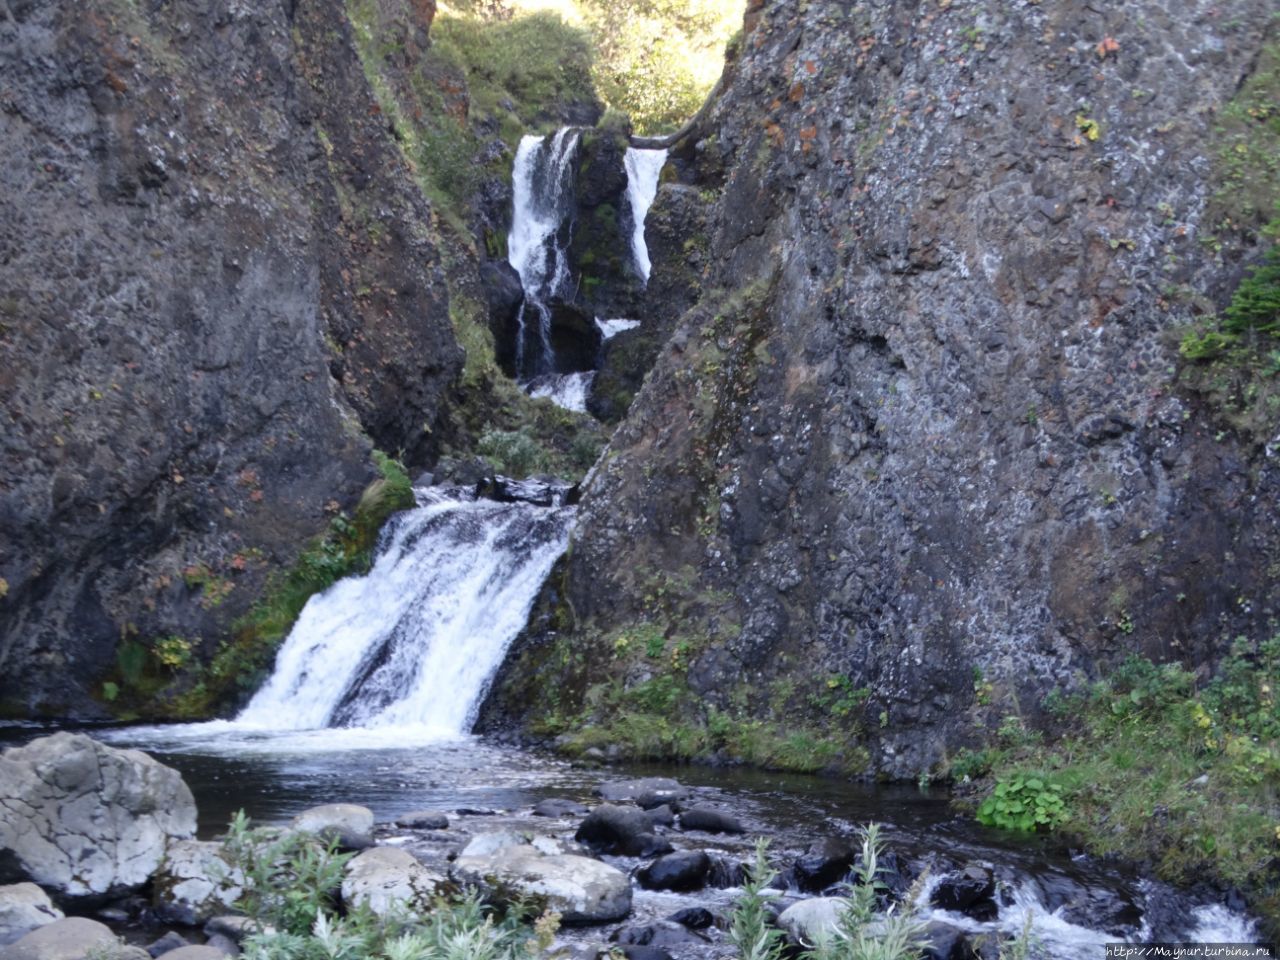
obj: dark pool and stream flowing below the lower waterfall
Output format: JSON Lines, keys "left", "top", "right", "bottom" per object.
{"left": 0, "top": 723, "right": 1254, "bottom": 960}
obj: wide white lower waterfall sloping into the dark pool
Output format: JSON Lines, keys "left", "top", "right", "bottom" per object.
{"left": 237, "top": 489, "right": 573, "bottom": 736}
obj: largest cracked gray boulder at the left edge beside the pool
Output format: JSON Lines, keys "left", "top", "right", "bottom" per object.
{"left": 0, "top": 733, "right": 196, "bottom": 900}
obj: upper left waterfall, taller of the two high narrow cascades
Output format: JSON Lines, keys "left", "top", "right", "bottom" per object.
{"left": 507, "top": 127, "right": 579, "bottom": 380}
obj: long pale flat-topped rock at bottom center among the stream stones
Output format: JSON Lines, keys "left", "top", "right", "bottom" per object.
{"left": 452, "top": 841, "right": 631, "bottom": 924}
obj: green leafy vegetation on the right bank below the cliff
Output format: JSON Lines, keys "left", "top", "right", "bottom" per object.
{"left": 952, "top": 636, "right": 1280, "bottom": 896}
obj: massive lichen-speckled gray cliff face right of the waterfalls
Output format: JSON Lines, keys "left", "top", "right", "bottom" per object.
{"left": 494, "top": 0, "right": 1280, "bottom": 774}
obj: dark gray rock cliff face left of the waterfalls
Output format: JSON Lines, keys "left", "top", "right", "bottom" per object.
{"left": 0, "top": 0, "right": 462, "bottom": 714}
